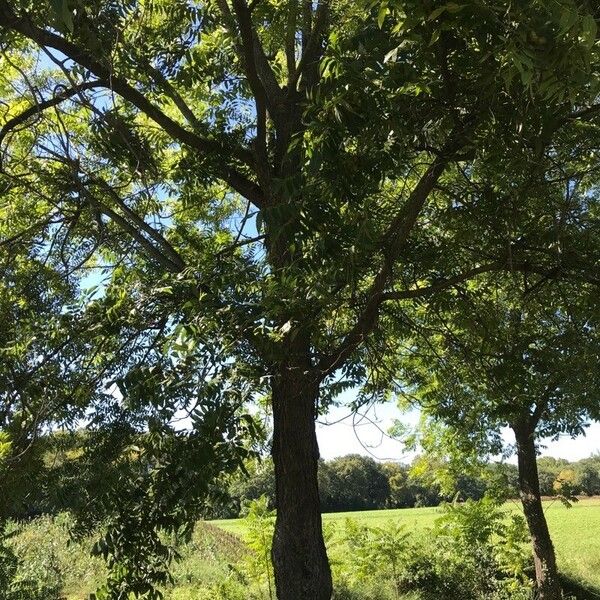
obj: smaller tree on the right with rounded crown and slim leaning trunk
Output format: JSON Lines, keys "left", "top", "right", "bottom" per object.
{"left": 394, "top": 274, "right": 600, "bottom": 598}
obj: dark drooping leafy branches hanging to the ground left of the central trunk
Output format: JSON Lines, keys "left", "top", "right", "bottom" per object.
{"left": 86, "top": 409, "right": 258, "bottom": 598}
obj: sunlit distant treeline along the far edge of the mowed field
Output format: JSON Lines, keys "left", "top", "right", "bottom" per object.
{"left": 214, "top": 454, "right": 600, "bottom": 517}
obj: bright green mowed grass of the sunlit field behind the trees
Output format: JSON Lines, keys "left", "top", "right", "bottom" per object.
{"left": 212, "top": 498, "right": 600, "bottom": 592}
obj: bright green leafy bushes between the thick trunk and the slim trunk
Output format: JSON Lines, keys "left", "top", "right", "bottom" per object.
{"left": 332, "top": 498, "right": 532, "bottom": 600}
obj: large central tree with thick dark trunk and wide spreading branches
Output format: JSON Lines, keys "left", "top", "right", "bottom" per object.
{"left": 0, "top": 0, "right": 598, "bottom": 600}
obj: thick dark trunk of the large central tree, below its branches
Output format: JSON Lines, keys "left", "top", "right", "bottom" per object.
{"left": 272, "top": 353, "right": 332, "bottom": 600}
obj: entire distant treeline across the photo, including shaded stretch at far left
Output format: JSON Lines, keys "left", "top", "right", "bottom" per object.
{"left": 5, "top": 432, "right": 600, "bottom": 519}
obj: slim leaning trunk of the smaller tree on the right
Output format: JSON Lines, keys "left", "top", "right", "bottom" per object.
{"left": 513, "top": 426, "right": 562, "bottom": 600}
